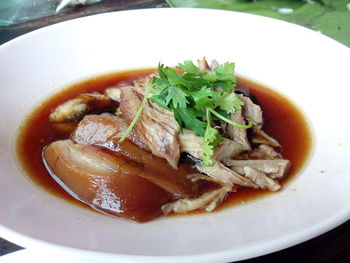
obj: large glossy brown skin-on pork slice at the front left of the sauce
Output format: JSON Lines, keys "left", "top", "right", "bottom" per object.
{"left": 43, "top": 140, "right": 172, "bottom": 222}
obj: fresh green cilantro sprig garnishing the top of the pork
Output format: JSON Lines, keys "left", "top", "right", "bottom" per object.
{"left": 120, "top": 60, "right": 252, "bottom": 166}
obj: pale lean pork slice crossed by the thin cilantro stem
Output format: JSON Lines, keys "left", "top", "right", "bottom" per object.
{"left": 118, "top": 85, "right": 180, "bottom": 169}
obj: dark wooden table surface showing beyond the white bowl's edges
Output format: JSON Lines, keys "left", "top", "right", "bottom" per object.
{"left": 0, "top": 0, "right": 350, "bottom": 263}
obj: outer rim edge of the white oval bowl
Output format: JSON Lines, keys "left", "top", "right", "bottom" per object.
{"left": 0, "top": 8, "right": 350, "bottom": 263}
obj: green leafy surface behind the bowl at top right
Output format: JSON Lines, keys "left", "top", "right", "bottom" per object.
{"left": 167, "top": 0, "right": 350, "bottom": 47}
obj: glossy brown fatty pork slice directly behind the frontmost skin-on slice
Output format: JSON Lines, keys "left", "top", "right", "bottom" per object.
{"left": 71, "top": 114, "right": 202, "bottom": 197}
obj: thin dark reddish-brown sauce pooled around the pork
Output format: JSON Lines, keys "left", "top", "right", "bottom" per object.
{"left": 17, "top": 69, "right": 312, "bottom": 216}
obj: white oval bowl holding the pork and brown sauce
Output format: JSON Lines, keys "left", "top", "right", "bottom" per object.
{"left": 0, "top": 9, "right": 350, "bottom": 262}
